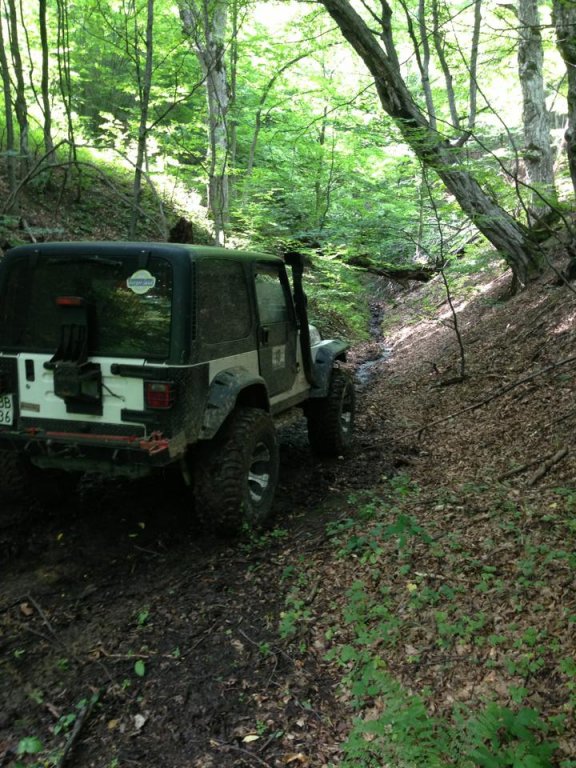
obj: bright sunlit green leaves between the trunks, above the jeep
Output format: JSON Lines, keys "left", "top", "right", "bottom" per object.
{"left": 0, "top": 0, "right": 565, "bottom": 290}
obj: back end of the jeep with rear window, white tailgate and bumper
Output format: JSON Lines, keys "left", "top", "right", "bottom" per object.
{"left": 0, "top": 243, "right": 198, "bottom": 476}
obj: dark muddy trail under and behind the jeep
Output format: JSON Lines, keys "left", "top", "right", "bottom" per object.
{"left": 0, "top": 390, "right": 388, "bottom": 768}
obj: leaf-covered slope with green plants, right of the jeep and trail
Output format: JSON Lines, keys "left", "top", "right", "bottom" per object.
{"left": 315, "top": 250, "right": 576, "bottom": 766}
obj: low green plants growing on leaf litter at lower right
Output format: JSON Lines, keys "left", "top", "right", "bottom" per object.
{"left": 326, "top": 475, "right": 576, "bottom": 768}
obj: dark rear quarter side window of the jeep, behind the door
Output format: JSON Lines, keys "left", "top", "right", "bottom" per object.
{"left": 198, "top": 259, "right": 251, "bottom": 344}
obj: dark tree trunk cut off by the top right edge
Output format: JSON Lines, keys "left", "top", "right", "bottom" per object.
{"left": 552, "top": 0, "right": 576, "bottom": 196}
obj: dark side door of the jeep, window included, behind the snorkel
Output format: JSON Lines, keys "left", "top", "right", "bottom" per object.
{"left": 254, "top": 263, "right": 298, "bottom": 396}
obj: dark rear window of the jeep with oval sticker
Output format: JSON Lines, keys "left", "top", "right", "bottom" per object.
{"left": 0, "top": 256, "right": 173, "bottom": 359}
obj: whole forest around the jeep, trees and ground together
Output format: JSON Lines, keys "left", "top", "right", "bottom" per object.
{"left": 0, "top": 0, "right": 576, "bottom": 768}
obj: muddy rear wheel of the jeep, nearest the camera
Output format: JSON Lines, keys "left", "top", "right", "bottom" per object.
{"left": 193, "top": 408, "right": 279, "bottom": 535}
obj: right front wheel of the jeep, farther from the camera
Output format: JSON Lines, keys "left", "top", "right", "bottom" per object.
{"left": 306, "top": 368, "right": 356, "bottom": 456}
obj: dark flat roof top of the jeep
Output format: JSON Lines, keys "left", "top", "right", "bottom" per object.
{"left": 6, "top": 240, "right": 283, "bottom": 263}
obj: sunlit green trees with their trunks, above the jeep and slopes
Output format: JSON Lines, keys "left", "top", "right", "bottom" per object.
{"left": 0, "top": 0, "right": 576, "bottom": 284}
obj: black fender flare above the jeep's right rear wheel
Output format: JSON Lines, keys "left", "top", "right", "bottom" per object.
{"left": 200, "top": 367, "right": 270, "bottom": 440}
